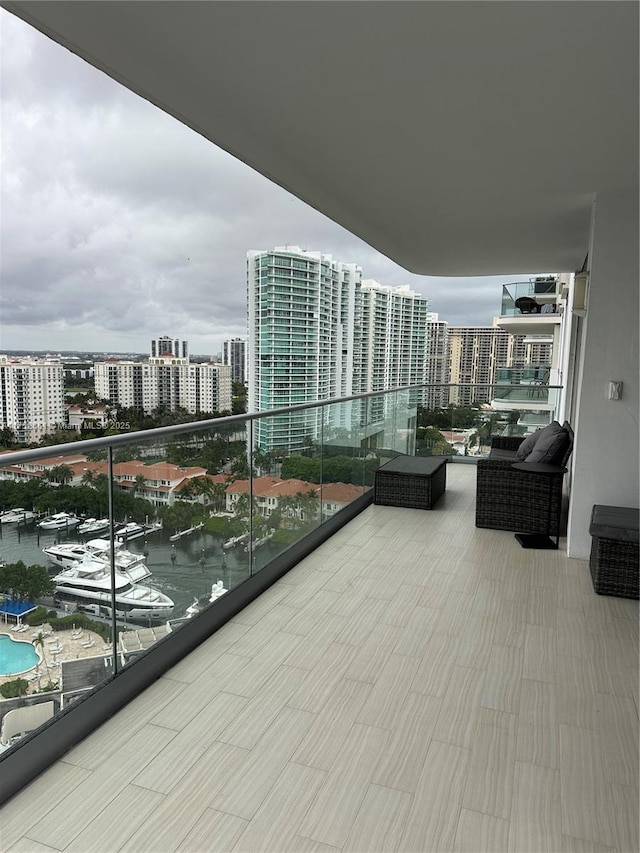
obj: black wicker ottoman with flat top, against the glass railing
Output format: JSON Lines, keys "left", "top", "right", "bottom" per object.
{"left": 373, "top": 456, "right": 447, "bottom": 509}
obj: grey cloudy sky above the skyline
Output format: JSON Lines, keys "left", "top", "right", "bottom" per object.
{"left": 0, "top": 10, "right": 552, "bottom": 355}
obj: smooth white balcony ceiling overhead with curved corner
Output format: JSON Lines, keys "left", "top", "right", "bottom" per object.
{"left": 2, "top": 0, "right": 638, "bottom": 275}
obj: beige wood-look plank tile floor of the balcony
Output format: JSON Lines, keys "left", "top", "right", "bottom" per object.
{"left": 0, "top": 465, "right": 639, "bottom": 853}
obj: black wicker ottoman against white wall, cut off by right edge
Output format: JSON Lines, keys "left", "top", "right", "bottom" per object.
{"left": 589, "top": 504, "right": 640, "bottom": 598}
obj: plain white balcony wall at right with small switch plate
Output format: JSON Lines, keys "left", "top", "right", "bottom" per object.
{"left": 567, "top": 191, "right": 639, "bottom": 559}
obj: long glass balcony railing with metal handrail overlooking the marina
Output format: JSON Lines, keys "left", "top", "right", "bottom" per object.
{"left": 0, "top": 382, "right": 551, "bottom": 762}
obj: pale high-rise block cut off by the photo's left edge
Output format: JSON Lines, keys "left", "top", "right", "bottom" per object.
{"left": 0, "top": 355, "right": 66, "bottom": 442}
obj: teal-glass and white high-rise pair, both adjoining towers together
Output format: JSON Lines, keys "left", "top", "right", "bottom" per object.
{"left": 247, "top": 246, "right": 427, "bottom": 450}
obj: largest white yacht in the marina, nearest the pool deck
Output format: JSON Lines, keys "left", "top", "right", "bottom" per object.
{"left": 53, "top": 560, "right": 174, "bottom": 624}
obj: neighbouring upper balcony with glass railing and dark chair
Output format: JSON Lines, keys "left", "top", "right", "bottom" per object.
{"left": 497, "top": 276, "right": 561, "bottom": 335}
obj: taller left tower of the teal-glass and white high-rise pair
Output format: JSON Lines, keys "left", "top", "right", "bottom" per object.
{"left": 247, "top": 246, "right": 362, "bottom": 450}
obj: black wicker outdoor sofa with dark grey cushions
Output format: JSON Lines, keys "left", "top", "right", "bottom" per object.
{"left": 476, "top": 421, "right": 574, "bottom": 537}
